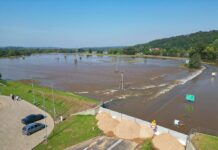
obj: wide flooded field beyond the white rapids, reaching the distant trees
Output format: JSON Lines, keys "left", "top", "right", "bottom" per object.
{"left": 0, "top": 54, "right": 189, "bottom": 101}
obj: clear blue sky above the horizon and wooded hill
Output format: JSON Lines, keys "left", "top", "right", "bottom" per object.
{"left": 0, "top": 0, "right": 218, "bottom": 48}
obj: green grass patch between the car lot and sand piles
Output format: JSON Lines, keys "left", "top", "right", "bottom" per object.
{"left": 34, "top": 115, "right": 102, "bottom": 150}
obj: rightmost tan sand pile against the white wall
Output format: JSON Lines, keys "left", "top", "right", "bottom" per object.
{"left": 152, "top": 133, "right": 185, "bottom": 150}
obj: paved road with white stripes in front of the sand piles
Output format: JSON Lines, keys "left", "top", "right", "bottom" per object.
{"left": 66, "top": 136, "right": 137, "bottom": 150}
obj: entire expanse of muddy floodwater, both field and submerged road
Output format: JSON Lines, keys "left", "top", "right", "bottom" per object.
{"left": 0, "top": 54, "right": 218, "bottom": 133}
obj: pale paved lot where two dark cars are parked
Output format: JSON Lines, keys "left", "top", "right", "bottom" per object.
{"left": 0, "top": 96, "right": 54, "bottom": 150}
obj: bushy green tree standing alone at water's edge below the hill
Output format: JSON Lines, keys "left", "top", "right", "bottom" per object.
{"left": 189, "top": 52, "right": 201, "bottom": 69}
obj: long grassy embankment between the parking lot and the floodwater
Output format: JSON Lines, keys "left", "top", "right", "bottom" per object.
{"left": 0, "top": 81, "right": 98, "bottom": 117}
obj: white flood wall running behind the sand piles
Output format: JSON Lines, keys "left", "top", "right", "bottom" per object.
{"left": 98, "top": 107, "right": 188, "bottom": 145}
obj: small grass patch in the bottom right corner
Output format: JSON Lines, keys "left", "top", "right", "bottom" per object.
{"left": 192, "top": 134, "right": 218, "bottom": 150}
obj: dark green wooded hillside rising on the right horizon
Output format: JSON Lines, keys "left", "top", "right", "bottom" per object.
{"left": 108, "top": 30, "right": 218, "bottom": 61}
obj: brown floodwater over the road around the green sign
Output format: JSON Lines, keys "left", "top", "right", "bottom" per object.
{"left": 108, "top": 65, "right": 218, "bottom": 135}
